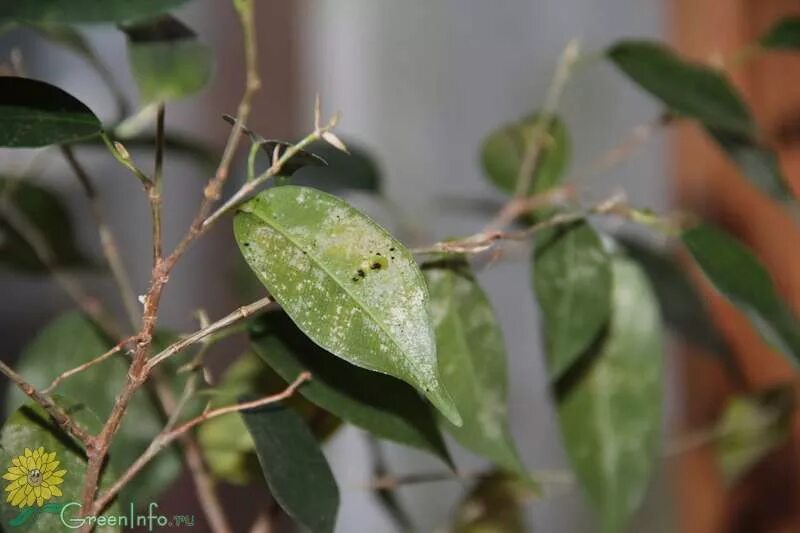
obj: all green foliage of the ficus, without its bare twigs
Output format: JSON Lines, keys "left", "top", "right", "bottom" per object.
{"left": 0, "top": 0, "right": 800, "bottom": 533}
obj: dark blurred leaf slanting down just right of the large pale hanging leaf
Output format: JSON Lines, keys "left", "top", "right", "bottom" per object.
{"left": 624, "top": 240, "right": 731, "bottom": 359}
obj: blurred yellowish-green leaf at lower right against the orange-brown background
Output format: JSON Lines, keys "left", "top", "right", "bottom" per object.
{"left": 714, "top": 386, "right": 795, "bottom": 485}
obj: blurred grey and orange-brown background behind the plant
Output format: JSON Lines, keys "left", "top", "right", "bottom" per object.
{"left": 0, "top": 0, "right": 800, "bottom": 533}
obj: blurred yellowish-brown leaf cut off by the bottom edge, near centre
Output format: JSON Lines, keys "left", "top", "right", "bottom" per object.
{"left": 453, "top": 472, "right": 532, "bottom": 533}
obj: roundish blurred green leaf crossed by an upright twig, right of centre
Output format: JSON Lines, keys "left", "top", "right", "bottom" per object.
{"left": 481, "top": 113, "right": 571, "bottom": 194}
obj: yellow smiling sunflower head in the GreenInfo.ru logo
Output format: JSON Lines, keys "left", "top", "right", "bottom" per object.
{"left": 3, "top": 447, "right": 67, "bottom": 508}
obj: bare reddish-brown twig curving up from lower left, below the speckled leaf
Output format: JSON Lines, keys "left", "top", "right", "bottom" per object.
{"left": 92, "top": 372, "right": 311, "bottom": 514}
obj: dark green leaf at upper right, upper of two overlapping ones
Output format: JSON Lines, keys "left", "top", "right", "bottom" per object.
{"left": 608, "top": 41, "right": 756, "bottom": 138}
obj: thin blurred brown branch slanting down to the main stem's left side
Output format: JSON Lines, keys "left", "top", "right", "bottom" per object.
{"left": 61, "top": 145, "right": 140, "bottom": 329}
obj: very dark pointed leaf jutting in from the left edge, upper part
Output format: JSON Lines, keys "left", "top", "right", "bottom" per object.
{"left": 0, "top": 77, "right": 102, "bottom": 148}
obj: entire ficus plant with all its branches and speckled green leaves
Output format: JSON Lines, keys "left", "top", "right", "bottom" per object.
{"left": 0, "top": 0, "right": 800, "bottom": 533}
